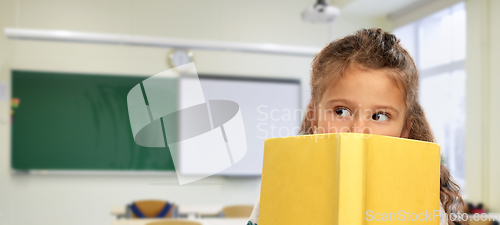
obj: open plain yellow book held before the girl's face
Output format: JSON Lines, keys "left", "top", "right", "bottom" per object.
{"left": 258, "top": 133, "right": 440, "bottom": 225}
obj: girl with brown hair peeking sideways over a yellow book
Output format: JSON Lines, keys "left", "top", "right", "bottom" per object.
{"left": 248, "top": 29, "right": 467, "bottom": 225}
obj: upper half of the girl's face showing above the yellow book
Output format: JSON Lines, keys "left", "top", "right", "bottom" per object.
{"left": 310, "top": 70, "right": 409, "bottom": 138}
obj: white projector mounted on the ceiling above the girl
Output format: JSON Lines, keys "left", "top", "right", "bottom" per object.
{"left": 302, "top": 0, "right": 340, "bottom": 23}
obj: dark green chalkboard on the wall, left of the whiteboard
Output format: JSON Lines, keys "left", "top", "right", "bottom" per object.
{"left": 11, "top": 70, "right": 175, "bottom": 171}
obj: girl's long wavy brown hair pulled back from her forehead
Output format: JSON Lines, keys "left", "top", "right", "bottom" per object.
{"left": 299, "top": 29, "right": 467, "bottom": 224}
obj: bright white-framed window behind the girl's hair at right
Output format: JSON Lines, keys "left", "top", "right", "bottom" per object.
{"left": 394, "top": 2, "right": 466, "bottom": 191}
